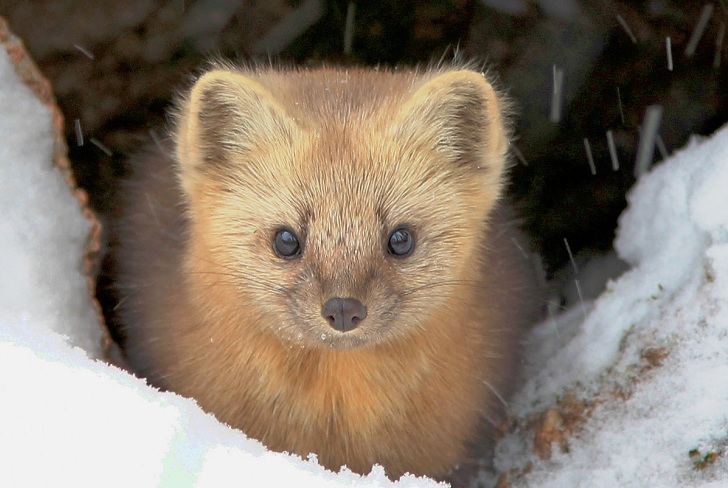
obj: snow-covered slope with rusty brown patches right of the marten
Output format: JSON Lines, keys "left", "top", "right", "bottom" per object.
{"left": 496, "top": 126, "right": 728, "bottom": 487}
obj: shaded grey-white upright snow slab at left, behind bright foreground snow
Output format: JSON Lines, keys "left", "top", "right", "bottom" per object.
{"left": 0, "top": 49, "right": 101, "bottom": 357}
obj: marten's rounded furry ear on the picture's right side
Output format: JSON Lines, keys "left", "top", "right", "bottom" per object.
{"left": 398, "top": 70, "right": 509, "bottom": 184}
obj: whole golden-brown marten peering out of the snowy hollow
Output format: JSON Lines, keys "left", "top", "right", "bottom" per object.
{"left": 109, "top": 66, "right": 533, "bottom": 479}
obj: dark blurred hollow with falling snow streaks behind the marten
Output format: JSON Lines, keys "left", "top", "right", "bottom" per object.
{"left": 0, "top": 0, "right": 728, "bottom": 276}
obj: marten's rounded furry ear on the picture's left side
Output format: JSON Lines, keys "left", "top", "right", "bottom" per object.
{"left": 177, "top": 70, "right": 295, "bottom": 187}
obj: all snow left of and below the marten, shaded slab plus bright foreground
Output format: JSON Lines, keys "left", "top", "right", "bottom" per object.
{"left": 0, "top": 43, "right": 435, "bottom": 488}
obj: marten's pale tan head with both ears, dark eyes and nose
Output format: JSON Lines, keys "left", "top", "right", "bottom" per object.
{"left": 176, "top": 69, "right": 508, "bottom": 349}
